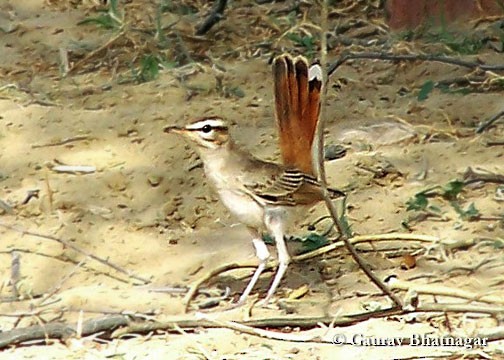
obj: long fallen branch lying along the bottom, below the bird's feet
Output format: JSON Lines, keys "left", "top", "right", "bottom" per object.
{"left": 0, "top": 303, "right": 504, "bottom": 349}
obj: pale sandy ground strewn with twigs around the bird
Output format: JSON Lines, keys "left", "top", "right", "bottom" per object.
{"left": 0, "top": 0, "right": 504, "bottom": 359}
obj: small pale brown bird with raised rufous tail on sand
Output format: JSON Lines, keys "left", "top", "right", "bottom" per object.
{"left": 164, "top": 54, "right": 345, "bottom": 305}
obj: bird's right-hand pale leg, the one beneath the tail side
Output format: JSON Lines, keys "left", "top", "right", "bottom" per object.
{"left": 262, "top": 210, "right": 290, "bottom": 305}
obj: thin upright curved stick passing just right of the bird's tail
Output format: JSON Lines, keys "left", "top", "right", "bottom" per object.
{"left": 312, "top": 0, "right": 402, "bottom": 308}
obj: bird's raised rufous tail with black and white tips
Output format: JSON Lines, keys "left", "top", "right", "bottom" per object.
{"left": 273, "top": 55, "right": 322, "bottom": 175}
